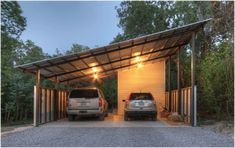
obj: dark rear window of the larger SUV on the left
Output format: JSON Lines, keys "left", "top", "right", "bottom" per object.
{"left": 69, "top": 89, "right": 98, "bottom": 98}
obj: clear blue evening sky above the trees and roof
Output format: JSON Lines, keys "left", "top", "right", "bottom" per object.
{"left": 19, "top": 1, "right": 122, "bottom": 55}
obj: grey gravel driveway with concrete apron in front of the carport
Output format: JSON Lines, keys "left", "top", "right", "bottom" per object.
{"left": 1, "top": 120, "right": 234, "bottom": 147}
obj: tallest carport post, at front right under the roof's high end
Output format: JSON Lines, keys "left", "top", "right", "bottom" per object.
{"left": 190, "top": 32, "right": 197, "bottom": 126}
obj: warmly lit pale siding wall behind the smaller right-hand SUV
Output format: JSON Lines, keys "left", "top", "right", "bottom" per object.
{"left": 118, "top": 60, "right": 165, "bottom": 115}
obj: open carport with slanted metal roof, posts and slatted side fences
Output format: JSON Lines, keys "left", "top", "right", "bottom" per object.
{"left": 16, "top": 19, "right": 210, "bottom": 126}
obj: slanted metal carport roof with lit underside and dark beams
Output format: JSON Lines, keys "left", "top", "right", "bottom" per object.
{"left": 16, "top": 19, "right": 210, "bottom": 83}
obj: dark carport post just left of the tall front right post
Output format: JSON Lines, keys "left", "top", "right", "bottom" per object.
{"left": 177, "top": 47, "right": 182, "bottom": 114}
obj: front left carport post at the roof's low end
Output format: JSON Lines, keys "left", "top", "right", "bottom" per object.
{"left": 34, "top": 67, "right": 40, "bottom": 126}
